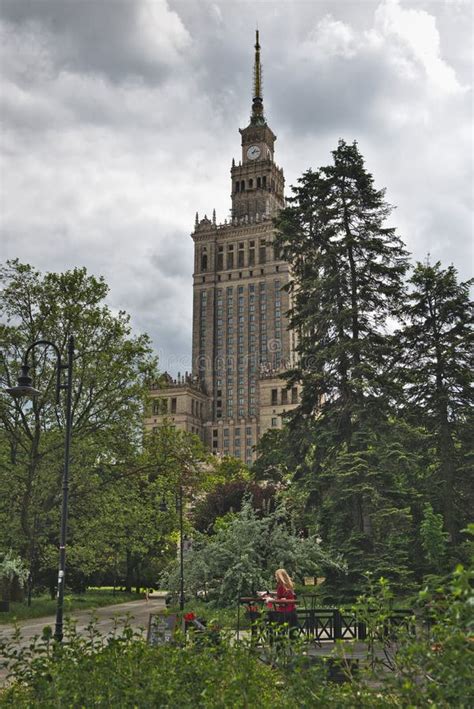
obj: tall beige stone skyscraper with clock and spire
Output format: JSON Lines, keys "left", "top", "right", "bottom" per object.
{"left": 146, "top": 30, "right": 298, "bottom": 464}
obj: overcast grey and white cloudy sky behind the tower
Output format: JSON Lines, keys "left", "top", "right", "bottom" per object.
{"left": 0, "top": 0, "right": 473, "bottom": 372}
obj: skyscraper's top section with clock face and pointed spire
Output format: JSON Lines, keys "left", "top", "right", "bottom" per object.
{"left": 231, "top": 30, "right": 285, "bottom": 221}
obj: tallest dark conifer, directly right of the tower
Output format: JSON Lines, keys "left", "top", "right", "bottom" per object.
{"left": 276, "top": 140, "right": 411, "bottom": 584}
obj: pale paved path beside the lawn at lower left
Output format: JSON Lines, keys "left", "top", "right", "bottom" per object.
{"left": 0, "top": 596, "right": 165, "bottom": 685}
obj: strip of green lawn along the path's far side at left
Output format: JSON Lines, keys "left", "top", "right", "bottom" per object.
{"left": 0, "top": 588, "right": 144, "bottom": 625}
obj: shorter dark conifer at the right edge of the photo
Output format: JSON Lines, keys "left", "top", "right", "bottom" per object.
{"left": 399, "top": 262, "right": 474, "bottom": 542}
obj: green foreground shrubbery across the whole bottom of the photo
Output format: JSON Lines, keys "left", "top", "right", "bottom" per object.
{"left": 0, "top": 552, "right": 474, "bottom": 709}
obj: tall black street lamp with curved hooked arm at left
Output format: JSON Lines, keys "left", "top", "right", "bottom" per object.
{"left": 5, "top": 335, "right": 74, "bottom": 642}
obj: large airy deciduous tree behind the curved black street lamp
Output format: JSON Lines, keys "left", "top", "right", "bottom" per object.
{"left": 0, "top": 261, "right": 156, "bottom": 582}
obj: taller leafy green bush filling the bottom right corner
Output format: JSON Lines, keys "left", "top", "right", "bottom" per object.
{"left": 346, "top": 525, "right": 474, "bottom": 708}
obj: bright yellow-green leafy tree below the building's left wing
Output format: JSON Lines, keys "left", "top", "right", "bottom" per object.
{"left": 55, "top": 423, "right": 212, "bottom": 590}
